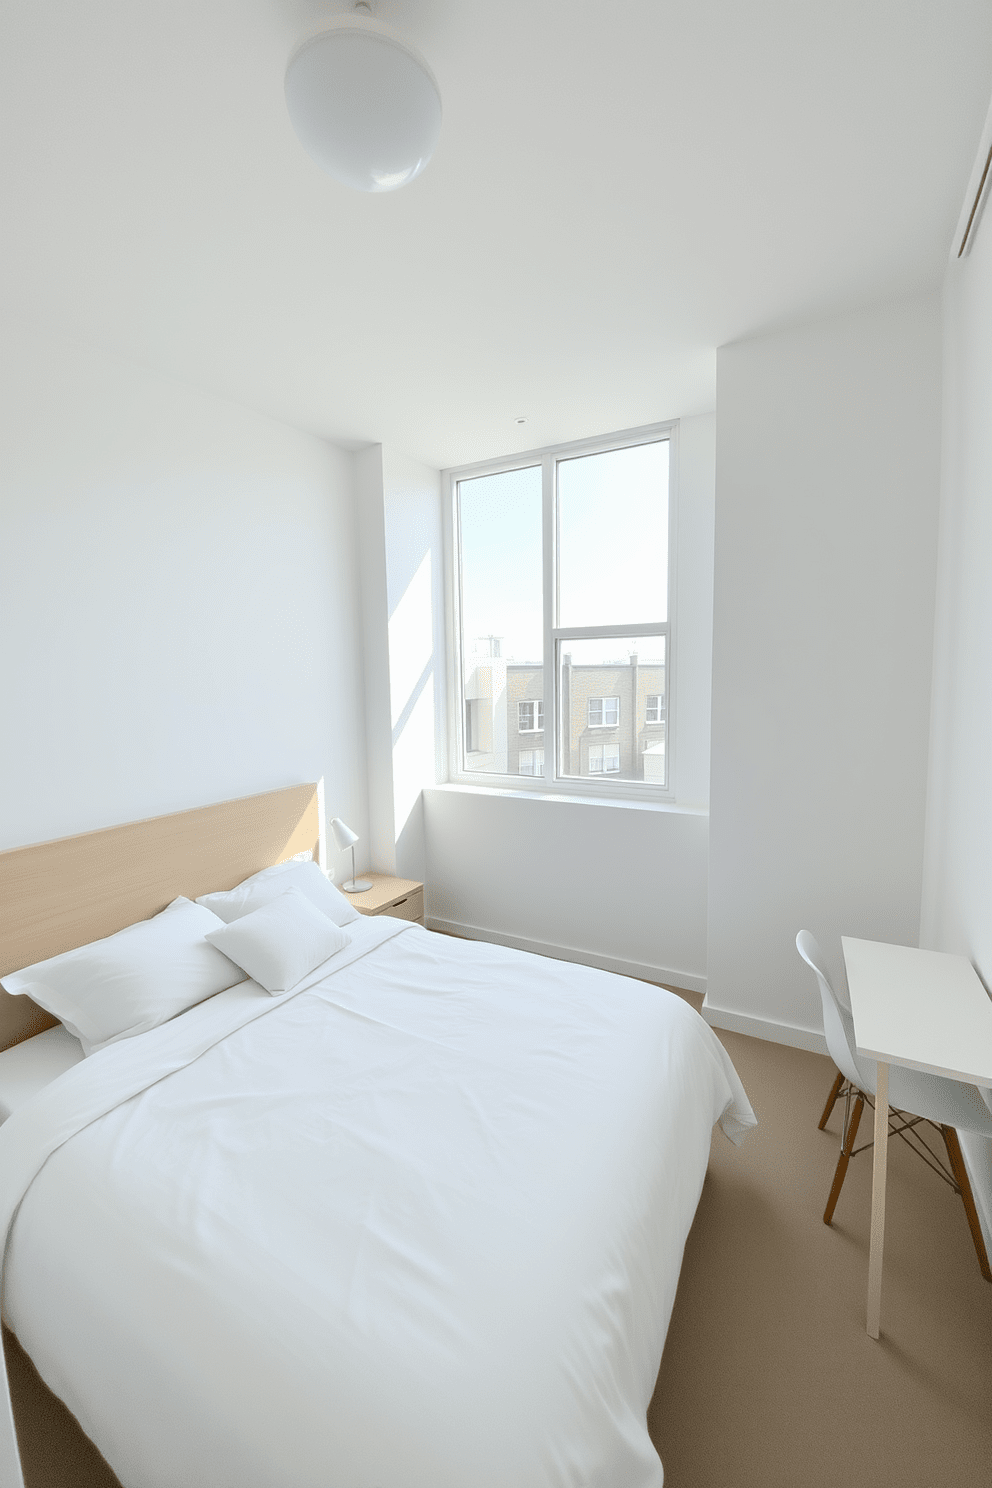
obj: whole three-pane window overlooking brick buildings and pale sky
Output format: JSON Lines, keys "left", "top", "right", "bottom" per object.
{"left": 451, "top": 426, "right": 677, "bottom": 795}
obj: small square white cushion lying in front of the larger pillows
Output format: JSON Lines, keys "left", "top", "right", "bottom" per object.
{"left": 207, "top": 888, "right": 351, "bottom": 995}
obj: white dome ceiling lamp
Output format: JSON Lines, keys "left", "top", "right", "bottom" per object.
{"left": 286, "top": 0, "right": 440, "bottom": 192}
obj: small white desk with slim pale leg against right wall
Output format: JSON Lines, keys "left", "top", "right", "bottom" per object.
{"left": 842, "top": 936, "right": 992, "bottom": 1338}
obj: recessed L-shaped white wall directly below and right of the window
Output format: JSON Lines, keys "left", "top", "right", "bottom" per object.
{"left": 424, "top": 415, "right": 714, "bottom": 991}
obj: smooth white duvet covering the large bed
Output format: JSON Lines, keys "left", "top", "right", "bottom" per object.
{"left": 0, "top": 920, "right": 754, "bottom": 1488}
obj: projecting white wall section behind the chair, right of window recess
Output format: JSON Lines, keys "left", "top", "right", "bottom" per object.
{"left": 706, "top": 296, "right": 940, "bottom": 1048}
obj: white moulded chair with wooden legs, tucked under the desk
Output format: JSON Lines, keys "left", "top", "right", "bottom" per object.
{"left": 796, "top": 930, "right": 992, "bottom": 1281}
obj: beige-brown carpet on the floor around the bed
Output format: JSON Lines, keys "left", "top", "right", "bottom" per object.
{"left": 4, "top": 1017, "right": 992, "bottom": 1488}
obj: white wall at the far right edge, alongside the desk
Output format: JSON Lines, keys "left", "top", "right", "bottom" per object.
{"left": 921, "top": 188, "right": 992, "bottom": 1251}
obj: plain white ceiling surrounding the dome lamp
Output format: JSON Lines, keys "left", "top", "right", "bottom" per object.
{"left": 0, "top": 0, "right": 992, "bottom": 466}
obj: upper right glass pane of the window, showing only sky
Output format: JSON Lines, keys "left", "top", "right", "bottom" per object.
{"left": 558, "top": 439, "right": 668, "bottom": 626}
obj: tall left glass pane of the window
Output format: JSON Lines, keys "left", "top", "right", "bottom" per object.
{"left": 458, "top": 466, "right": 544, "bottom": 775}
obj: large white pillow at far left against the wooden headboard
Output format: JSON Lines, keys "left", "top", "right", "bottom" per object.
{"left": 0, "top": 897, "right": 244, "bottom": 1054}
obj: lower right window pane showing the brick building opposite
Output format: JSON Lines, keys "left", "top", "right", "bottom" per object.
{"left": 558, "top": 635, "right": 668, "bottom": 786}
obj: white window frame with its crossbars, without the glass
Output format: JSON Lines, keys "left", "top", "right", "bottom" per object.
{"left": 442, "top": 420, "right": 678, "bottom": 802}
